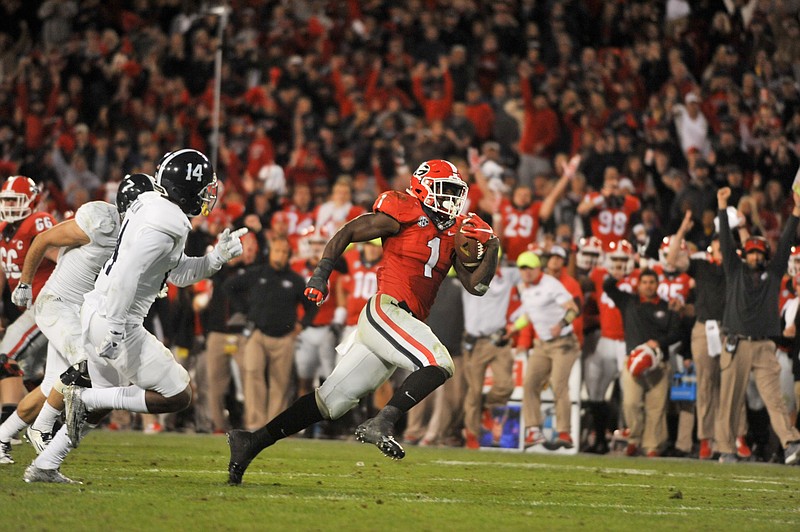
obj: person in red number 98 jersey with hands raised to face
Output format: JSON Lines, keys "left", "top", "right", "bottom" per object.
{"left": 577, "top": 168, "right": 642, "bottom": 251}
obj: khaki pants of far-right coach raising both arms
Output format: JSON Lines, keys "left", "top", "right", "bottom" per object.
{"left": 717, "top": 340, "right": 800, "bottom": 453}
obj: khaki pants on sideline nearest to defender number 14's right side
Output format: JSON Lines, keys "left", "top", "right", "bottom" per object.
{"left": 206, "top": 332, "right": 247, "bottom": 430}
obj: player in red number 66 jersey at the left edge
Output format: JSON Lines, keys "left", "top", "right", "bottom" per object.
{"left": 0, "top": 176, "right": 58, "bottom": 428}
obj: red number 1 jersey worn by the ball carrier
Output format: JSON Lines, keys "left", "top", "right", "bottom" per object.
{"left": 372, "top": 190, "right": 463, "bottom": 320}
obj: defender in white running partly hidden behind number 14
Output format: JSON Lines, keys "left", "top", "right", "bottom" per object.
{"left": 0, "top": 174, "right": 153, "bottom": 470}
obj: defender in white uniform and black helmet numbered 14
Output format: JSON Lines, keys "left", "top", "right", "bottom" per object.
{"left": 25, "top": 149, "right": 246, "bottom": 481}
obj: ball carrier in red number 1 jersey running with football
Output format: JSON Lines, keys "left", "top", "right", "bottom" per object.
{"left": 228, "top": 160, "right": 499, "bottom": 484}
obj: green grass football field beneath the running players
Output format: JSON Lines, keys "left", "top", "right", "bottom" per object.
{"left": 0, "top": 431, "right": 800, "bottom": 531}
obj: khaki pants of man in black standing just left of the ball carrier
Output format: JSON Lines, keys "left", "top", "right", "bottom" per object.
{"left": 242, "top": 330, "right": 295, "bottom": 430}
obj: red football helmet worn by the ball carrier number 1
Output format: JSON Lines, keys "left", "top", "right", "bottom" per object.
{"left": 408, "top": 159, "right": 468, "bottom": 230}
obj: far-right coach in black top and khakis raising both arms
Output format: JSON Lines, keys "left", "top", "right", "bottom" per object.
{"left": 717, "top": 187, "right": 800, "bottom": 465}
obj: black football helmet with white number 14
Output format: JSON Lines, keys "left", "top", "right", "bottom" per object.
{"left": 155, "top": 148, "right": 217, "bottom": 216}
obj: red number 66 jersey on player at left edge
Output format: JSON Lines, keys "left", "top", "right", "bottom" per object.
{"left": 0, "top": 212, "right": 56, "bottom": 299}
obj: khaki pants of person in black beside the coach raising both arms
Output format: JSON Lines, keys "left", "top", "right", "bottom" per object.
{"left": 692, "top": 321, "right": 747, "bottom": 440}
